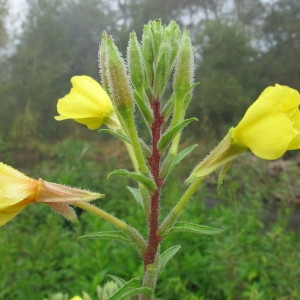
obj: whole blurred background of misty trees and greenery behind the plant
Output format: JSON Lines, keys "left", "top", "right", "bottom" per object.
{"left": 0, "top": 0, "right": 300, "bottom": 300}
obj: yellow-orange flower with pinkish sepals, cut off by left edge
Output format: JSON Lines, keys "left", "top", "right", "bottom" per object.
{"left": 0, "top": 162, "right": 103, "bottom": 226}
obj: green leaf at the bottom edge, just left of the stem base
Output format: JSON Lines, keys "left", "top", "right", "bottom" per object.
{"left": 107, "top": 278, "right": 153, "bottom": 300}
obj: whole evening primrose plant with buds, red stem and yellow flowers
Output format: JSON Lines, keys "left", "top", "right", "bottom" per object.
{"left": 0, "top": 20, "right": 300, "bottom": 300}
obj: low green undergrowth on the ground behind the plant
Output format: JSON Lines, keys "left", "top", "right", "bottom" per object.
{"left": 0, "top": 140, "right": 300, "bottom": 300}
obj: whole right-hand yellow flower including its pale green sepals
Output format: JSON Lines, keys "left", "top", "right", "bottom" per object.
{"left": 186, "top": 84, "right": 300, "bottom": 182}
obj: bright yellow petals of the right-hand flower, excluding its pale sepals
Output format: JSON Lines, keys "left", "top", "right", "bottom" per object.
{"left": 231, "top": 84, "right": 300, "bottom": 159}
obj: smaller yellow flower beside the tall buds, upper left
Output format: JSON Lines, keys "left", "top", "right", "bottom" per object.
{"left": 55, "top": 75, "right": 120, "bottom": 129}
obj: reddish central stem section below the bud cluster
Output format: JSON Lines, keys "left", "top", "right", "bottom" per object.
{"left": 144, "top": 99, "right": 164, "bottom": 269}
